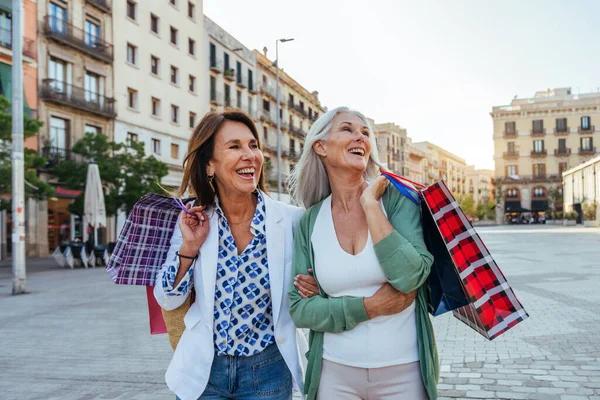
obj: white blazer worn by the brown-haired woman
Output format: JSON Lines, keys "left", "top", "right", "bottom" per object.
{"left": 154, "top": 194, "right": 308, "bottom": 400}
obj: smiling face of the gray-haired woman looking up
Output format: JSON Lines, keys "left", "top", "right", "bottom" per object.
{"left": 313, "top": 112, "right": 371, "bottom": 174}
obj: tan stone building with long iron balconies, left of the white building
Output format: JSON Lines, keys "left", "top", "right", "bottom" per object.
{"left": 37, "top": 0, "right": 116, "bottom": 254}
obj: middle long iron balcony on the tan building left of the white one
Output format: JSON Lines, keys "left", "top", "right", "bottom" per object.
{"left": 40, "top": 79, "right": 117, "bottom": 119}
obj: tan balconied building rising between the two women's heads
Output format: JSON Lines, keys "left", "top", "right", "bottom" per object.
{"left": 254, "top": 50, "right": 326, "bottom": 191}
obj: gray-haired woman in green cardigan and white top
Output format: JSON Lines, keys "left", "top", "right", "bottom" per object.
{"left": 288, "top": 107, "right": 438, "bottom": 400}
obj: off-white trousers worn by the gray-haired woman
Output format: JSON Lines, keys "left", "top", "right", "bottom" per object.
{"left": 317, "top": 359, "right": 428, "bottom": 400}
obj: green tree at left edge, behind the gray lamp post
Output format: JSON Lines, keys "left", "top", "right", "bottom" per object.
{"left": 0, "top": 96, "right": 54, "bottom": 210}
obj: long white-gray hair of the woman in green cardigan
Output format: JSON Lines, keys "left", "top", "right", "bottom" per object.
{"left": 288, "top": 107, "right": 381, "bottom": 208}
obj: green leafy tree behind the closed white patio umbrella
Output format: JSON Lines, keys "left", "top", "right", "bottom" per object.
{"left": 52, "top": 133, "right": 169, "bottom": 216}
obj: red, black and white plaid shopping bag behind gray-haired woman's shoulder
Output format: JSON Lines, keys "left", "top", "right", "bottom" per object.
{"left": 384, "top": 172, "right": 528, "bottom": 340}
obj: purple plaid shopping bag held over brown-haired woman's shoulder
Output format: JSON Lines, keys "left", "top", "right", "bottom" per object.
{"left": 106, "top": 193, "right": 191, "bottom": 286}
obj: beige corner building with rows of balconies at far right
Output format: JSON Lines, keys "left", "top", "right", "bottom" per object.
{"left": 490, "top": 88, "right": 600, "bottom": 214}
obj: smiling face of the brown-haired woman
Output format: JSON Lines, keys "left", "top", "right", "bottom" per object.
{"left": 207, "top": 121, "right": 264, "bottom": 196}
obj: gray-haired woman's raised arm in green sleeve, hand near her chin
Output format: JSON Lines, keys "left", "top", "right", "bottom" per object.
{"left": 361, "top": 176, "right": 433, "bottom": 293}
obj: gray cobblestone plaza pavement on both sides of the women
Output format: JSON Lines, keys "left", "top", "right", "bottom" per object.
{"left": 0, "top": 226, "right": 600, "bottom": 400}
